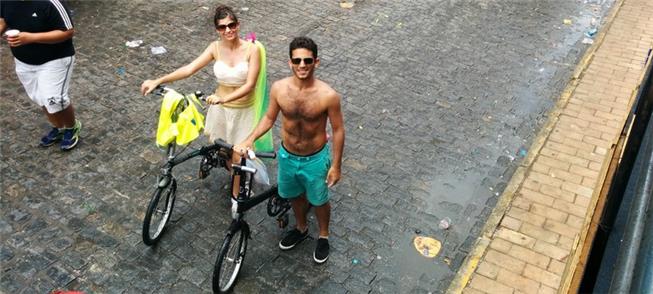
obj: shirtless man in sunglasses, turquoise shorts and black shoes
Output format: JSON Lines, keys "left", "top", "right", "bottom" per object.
{"left": 234, "top": 37, "right": 345, "bottom": 263}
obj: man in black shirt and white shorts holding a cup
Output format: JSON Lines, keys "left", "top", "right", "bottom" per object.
{"left": 0, "top": 0, "right": 82, "bottom": 150}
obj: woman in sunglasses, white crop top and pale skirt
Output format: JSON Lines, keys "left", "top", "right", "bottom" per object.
{"left": 141, "top": 5, "right": 261, "bottom": 144}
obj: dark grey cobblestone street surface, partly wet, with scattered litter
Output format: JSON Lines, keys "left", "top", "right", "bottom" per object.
{"left": 0, "top": 0, "right": 610, "bottom": 293}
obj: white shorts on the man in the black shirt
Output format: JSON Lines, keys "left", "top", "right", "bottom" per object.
{"left": 14, "top": 56, "right": 75, "bottom": 113}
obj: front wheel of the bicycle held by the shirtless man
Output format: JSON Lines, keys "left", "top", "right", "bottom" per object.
{"left": 213, "top": 226, "right": 247, "bottom": 293}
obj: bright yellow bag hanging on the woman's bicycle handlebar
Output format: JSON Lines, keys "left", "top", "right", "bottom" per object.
{"left": 156, "top": 89, "right": 204, "bottom": 147}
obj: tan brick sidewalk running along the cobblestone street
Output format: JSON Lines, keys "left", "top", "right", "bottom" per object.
{"left": 449, "top": 0, "right": 653, "bottom": 293}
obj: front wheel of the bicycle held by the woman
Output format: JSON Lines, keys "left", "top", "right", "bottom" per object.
{"left": 143, "top": 179, "right": 177, "bottom": 246}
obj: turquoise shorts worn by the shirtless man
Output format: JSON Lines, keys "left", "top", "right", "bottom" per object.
{"left": 277, "top": 144, "right": 331, "bottom": 206}
